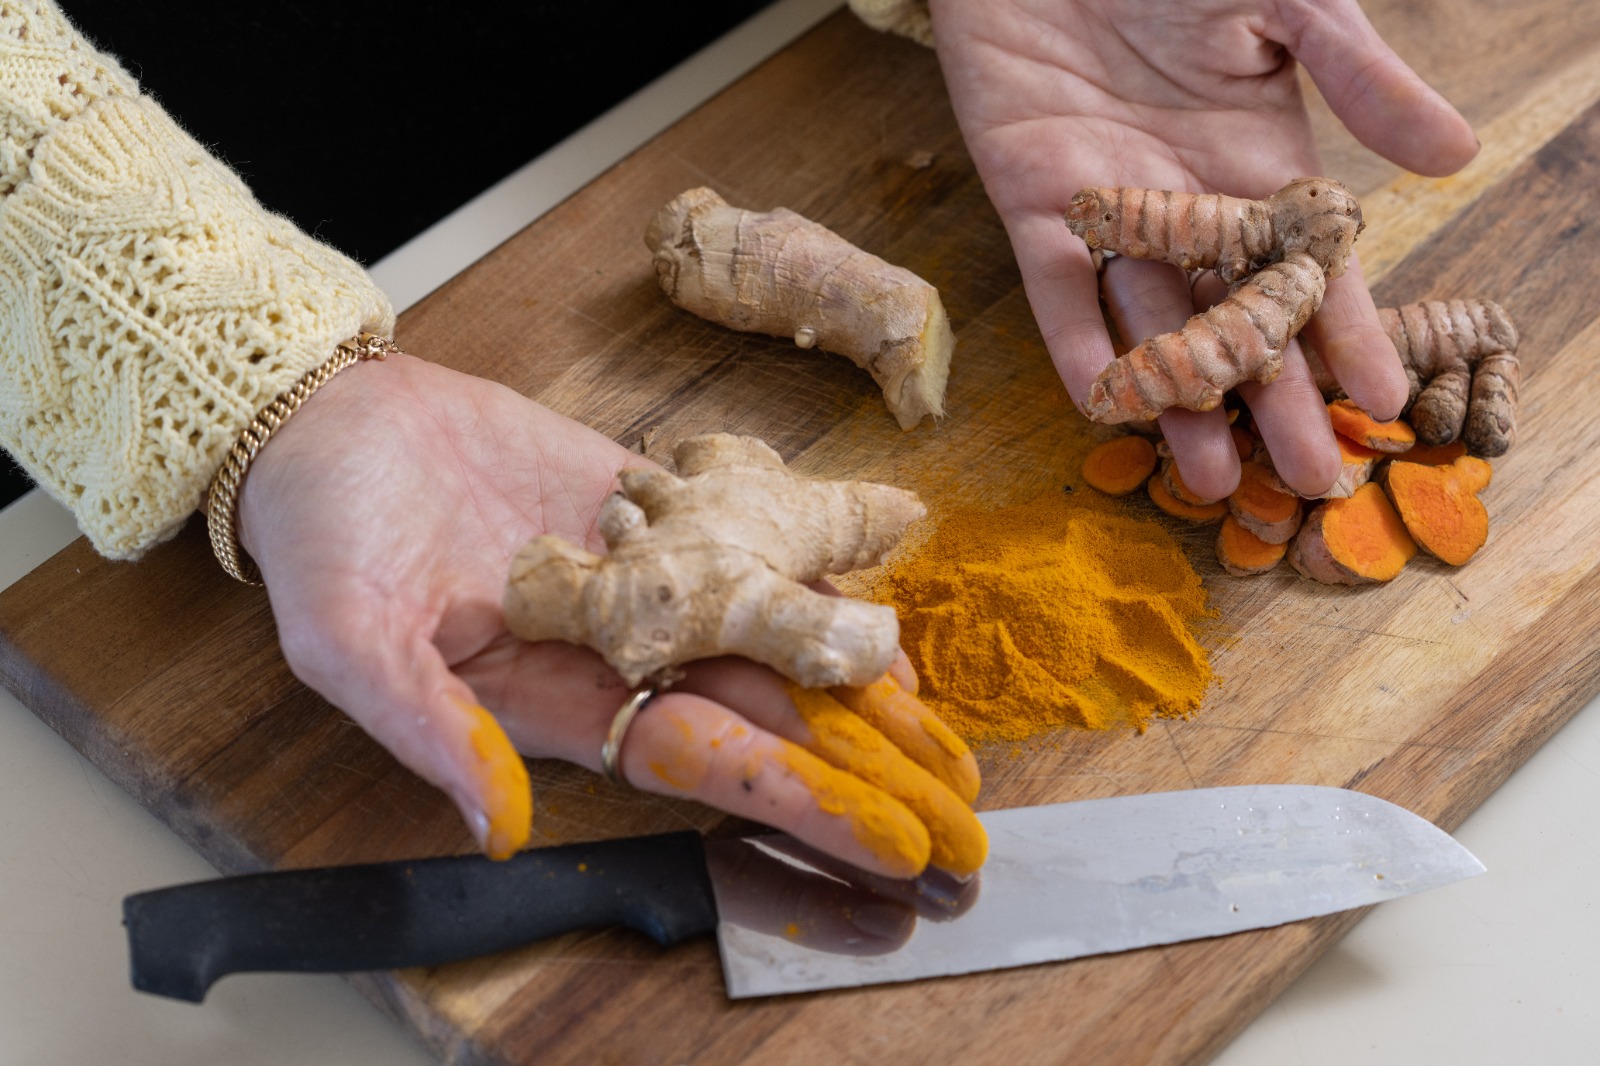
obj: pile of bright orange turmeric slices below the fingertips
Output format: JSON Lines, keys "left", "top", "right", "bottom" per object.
{"left": 1083, "top": 393, "right": 1491, "bottom": 584}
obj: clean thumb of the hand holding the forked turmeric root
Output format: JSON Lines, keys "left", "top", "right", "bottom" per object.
{"left": 1282, "top": 0, "right": 1478, "bottom": 178}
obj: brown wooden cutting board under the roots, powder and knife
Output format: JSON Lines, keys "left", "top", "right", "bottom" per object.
{"left": 0, "top": 0, "right": 1600, "bottom": 1064}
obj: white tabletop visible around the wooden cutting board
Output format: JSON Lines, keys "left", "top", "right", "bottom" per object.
{"left": 0, "top": 0, "right": 1600, "bottom": 1066}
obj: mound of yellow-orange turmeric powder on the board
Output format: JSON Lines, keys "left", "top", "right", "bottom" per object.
{"left": 872, "top": 495, "right": 1211, "bottom": 744}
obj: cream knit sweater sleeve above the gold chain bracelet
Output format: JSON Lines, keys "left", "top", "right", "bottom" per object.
{"left": 0, "top": 0, "right": 394, "bottom": 559}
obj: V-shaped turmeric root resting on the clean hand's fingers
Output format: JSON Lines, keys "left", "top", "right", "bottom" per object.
{"left": 1067, "top": 178, "right": 1362, "bottom": 423}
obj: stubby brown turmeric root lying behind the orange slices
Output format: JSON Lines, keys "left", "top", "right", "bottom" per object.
{"left": 1306, "top": 299, "right": 1522, "bottom": 458}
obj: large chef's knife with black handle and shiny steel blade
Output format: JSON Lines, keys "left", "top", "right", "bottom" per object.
{"left": 123, "top": 784, "right": 1483, "bottom": 1002}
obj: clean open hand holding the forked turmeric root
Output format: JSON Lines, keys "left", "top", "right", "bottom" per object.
{"left": 930, "top": 0, "right": 1477, "bottom": 498}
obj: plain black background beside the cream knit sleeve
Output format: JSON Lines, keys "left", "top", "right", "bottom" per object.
{"left": 0, "top": 0, "right": 771, "bottom": 504}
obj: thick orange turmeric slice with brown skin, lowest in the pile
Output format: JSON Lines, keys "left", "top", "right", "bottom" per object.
{"left": 1288, "top": 482, "right": 1416, "bottom": 584}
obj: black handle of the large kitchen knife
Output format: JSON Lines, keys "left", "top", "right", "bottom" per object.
{"left": 122, "top": 831, "right": 717, "bottom": 1004}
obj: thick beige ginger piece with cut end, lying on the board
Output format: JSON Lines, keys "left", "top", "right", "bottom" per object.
{"left": 645, "top": 189, "right": 955, "bottom": 429}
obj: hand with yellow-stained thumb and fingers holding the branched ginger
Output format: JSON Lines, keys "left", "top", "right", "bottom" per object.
{"left": 238, "top": 347, "right": 976, "bottom": 877}
